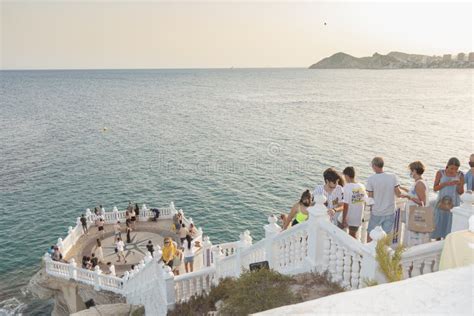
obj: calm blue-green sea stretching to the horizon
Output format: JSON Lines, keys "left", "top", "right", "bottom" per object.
{"left": 0, "top": 69, "right": 473, "bottom": 314}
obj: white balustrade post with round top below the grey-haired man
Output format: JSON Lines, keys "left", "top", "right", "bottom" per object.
{"left": 360, "top": 226, "right": 387, "bottom": 287}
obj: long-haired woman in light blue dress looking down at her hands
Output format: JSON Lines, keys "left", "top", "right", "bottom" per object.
{"left": 431, "top": 157, "right": 464, "bottom": 240}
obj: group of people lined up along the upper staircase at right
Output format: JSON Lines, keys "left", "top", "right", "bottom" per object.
{"left": 280, "top": 154, "right": 474, "bottom": 246}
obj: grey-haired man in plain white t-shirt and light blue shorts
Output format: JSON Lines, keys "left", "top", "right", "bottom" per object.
{"left": 367, "top": 157, "right": 402, "bottom": 242}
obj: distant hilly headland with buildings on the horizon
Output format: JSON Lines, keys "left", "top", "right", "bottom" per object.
{"left": 309, "top": 52, "right": 474, "bottom": 69}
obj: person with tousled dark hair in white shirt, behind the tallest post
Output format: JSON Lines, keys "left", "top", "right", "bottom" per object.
{"left": 313, "top": 168, "right": 344, "bottom": 228}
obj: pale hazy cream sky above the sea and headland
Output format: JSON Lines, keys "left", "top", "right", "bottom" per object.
{"left": 0, "top": 0, "right": 473, "bottom": 69}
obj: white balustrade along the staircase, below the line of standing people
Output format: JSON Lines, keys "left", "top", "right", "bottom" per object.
{"left": 168, "top": 190, "right": 474, "bottom": 308}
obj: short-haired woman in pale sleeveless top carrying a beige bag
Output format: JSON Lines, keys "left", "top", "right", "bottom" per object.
{"left": 400, "top": 161, "right": 430, "bottom": 247}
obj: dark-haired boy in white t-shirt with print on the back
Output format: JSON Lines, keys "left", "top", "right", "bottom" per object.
{"left": 342, "top": 167, "right": 367, "bottom": 238}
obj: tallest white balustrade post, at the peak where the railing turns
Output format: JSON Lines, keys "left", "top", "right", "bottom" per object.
{"left": 307, "top": 195, "right": 329, "bottom": 273}
